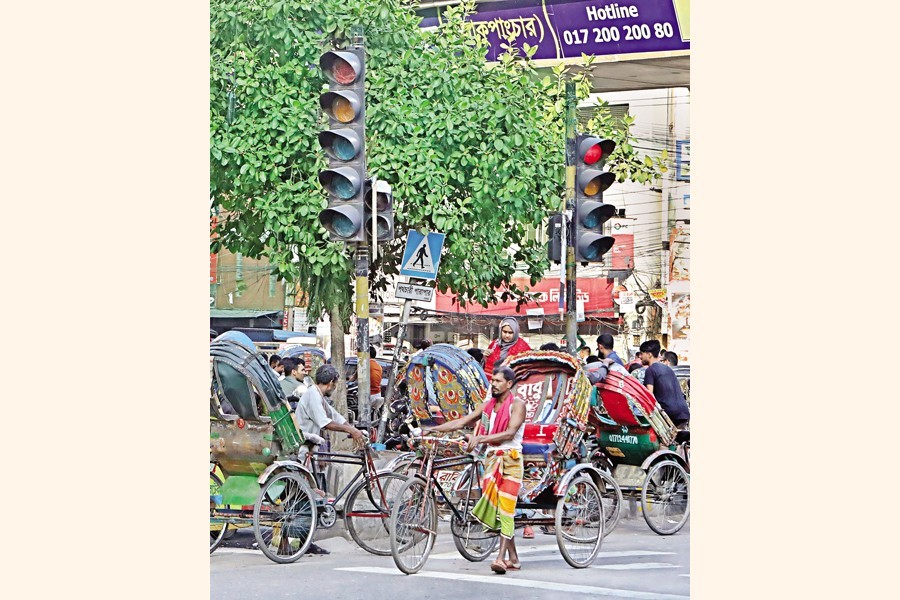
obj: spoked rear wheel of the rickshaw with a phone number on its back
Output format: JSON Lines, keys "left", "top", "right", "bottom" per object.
{"left": 641, "top": 460, "right": 691, "bottom": 535}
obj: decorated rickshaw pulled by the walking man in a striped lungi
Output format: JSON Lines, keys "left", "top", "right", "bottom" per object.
{"left": 390, "top": 351, "right": 607, "bottom": 574}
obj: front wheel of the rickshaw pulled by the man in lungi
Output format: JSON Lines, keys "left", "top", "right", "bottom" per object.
{"left": 390, "top": 477, "right": 437, "bottom": 575}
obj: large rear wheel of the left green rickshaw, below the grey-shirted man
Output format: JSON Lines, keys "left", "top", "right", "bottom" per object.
{"left": 253, "top": 471, "right": 316, "bottom": 563}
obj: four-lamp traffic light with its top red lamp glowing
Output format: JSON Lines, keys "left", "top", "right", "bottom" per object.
{"left": 574, "top": 134, "right": 616, "bottom": 263}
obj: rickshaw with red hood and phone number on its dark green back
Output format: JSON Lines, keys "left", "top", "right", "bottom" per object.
{"left": 589, "top": 370, "right": 690, "bottom": 535}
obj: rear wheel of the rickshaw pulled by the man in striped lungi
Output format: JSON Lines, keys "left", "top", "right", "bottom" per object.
{"left": 556, "top": 477, "right": 604, "bottom": 569}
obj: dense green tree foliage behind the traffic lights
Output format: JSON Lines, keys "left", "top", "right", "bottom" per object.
{"left": 210, "top": 0, "right": 659, "bottom": 322}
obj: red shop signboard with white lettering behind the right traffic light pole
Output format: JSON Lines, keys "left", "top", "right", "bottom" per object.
{"left": 434, "top": 277, "right": 614, "bottom": 316}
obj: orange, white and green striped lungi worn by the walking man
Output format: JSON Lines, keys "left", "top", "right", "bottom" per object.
{"left": 472, "top": 450, "right": 523, "bottom": 539}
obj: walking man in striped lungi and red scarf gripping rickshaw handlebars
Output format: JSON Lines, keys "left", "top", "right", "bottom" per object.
{"left": 426, "top": 366, "right": 525, "bottom": 575}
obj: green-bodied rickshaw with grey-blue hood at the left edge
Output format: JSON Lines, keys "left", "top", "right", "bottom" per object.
{"left": 210, "top": 339, "right": 405, "bottom": 563}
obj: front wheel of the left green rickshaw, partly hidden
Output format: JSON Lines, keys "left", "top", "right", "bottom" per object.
{"left": 344, "top": 473, "right": 406, "bottom": 556}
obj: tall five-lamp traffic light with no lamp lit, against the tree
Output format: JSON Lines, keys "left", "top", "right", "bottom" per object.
{"left": 319, "top": 46, "right": 366, "bottom": 242}
